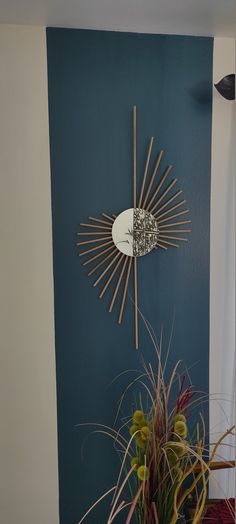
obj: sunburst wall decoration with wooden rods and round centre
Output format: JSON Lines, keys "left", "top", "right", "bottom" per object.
{"left": 77, "top": 106, "right": 191, "bottom": 349}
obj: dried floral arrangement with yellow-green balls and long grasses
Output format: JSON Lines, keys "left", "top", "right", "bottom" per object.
{"left": 79, "top": 334, "right": 234, "bottom": 524}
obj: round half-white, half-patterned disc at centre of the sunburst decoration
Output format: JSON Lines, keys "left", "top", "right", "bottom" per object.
{"left": 112, "top": 208, "right": 159, "bottom": 257}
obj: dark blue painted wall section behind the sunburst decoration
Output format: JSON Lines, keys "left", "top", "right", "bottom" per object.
{"left": 47, "top": 29, "right": 213, "bottom": 524}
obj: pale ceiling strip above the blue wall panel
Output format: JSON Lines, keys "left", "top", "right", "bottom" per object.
{"left": 0, "top": 0, "right": 236, "bottom": 36}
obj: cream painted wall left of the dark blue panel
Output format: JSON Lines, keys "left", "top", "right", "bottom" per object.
{"left": 0, "top": 26, "right": 58, "bottom": 524}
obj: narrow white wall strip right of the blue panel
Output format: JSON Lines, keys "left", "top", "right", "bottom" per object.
{"left": 210, "top": 38, "right": 236, "bottom": 498}
